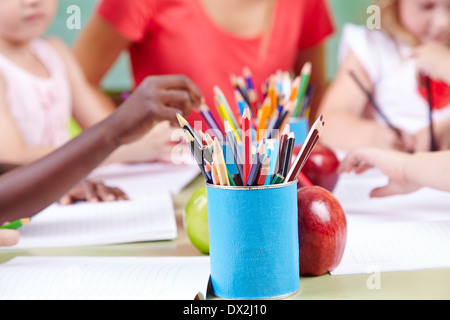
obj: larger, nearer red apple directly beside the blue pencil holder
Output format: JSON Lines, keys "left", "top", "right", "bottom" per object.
{"left": 297, "top": 186, "right": 347, "bottom": 276}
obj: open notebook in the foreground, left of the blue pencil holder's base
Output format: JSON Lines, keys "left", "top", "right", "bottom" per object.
{"left": 0, "top": 257, "right": 210, "bottom": 300}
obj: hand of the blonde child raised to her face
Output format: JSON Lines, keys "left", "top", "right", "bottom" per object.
{"left": 413, "top": 42, "right": 450, "bottom": 83}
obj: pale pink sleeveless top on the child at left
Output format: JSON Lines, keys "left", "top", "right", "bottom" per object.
{"left": 0, "top": 39, "right": 72, "bottom": 147}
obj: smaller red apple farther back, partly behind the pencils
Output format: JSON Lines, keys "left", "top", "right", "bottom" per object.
{"left": 293, "top": 144, "right": 339, "bottom": 192}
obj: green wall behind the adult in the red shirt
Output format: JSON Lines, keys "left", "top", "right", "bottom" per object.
{"left": 47, "top": 0, "right": 373, "bottom": 91}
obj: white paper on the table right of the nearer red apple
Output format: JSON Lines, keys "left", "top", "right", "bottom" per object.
{"left": 331, "top": 171, "right": 450, "bottom": 275}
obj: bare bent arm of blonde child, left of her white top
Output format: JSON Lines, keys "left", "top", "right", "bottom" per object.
{"left": 321, "top": 51, "right": 411, "bottom": 150}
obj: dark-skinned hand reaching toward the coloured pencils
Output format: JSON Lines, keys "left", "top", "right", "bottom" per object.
{"left": 113, "top": 75, "right": 202, "bottom": 144}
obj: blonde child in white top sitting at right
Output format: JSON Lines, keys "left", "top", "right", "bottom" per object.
{"left": 321, "top": 0, "right": 450, "bottom": 151}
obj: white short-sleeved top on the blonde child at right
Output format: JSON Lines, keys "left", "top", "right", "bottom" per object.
{"left": 339, "top": 24, "right": 450, "bottom": 134}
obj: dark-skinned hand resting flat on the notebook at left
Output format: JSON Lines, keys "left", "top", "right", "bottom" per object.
{"left": 59, "top": 180, "right": 128, "bottom": 205}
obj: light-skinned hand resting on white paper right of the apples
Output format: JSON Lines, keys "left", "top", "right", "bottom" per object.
{"left": 338, "top": 148, "right": 420, "bottom": 197}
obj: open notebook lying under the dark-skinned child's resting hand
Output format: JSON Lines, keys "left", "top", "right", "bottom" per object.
{"left": 4, "top": 194, "right": 177, "bottom": 249}
